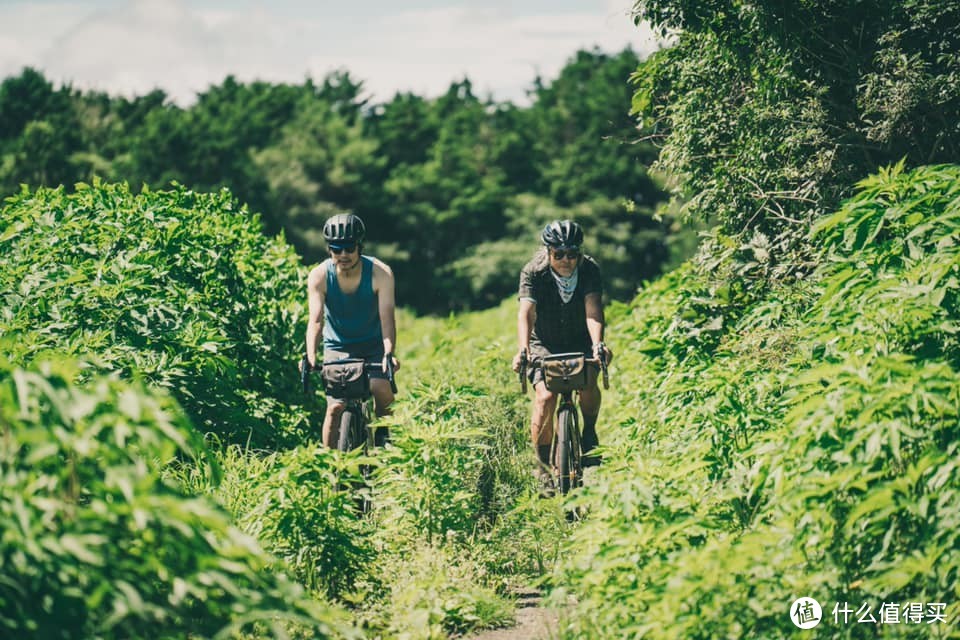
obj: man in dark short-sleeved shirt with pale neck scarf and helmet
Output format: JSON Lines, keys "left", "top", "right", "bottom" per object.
{"left": 513, "top": 220, "right": 613, "bottom": 489}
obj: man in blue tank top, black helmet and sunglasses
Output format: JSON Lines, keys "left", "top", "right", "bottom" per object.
{"left": 306, "top": 213, "right": 400, "bottom": 448}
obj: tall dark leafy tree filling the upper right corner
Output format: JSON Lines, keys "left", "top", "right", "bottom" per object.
{"left": 634, "top": 0, "right": 960, "bottom": 262}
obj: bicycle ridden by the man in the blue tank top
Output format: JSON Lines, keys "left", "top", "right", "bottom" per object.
{"left": 300, "top": 354, "right": 397, "bottom": 512}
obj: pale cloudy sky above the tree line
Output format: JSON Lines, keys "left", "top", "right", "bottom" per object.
{"left": 0, "top": 0, "right": 656, "bottom": 104}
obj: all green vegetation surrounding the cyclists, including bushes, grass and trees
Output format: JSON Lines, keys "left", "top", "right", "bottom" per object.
{"left": 0, "top": 0, "right": 960, "bottom": 639}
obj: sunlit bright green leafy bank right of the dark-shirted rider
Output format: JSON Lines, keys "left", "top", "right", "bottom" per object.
{"left": 562, "top": 166, "right": 960, "bottom": 638}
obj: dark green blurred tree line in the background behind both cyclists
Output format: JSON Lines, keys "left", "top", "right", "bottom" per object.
{"left": 0, "top": 49, "right": 669, "bottom": 312}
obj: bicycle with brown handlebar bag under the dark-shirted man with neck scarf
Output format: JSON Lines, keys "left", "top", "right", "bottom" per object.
{"left": 520, "top": 343, "right": 610, "bottom": 495}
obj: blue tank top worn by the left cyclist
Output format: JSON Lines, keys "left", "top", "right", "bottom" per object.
{"left": 323, "top": 256, "right": 383, "bottom": 356}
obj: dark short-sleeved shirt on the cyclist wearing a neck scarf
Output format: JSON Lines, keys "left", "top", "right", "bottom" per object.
{"left": 519, "top": 249, "right": 603, "bottom": 357}
